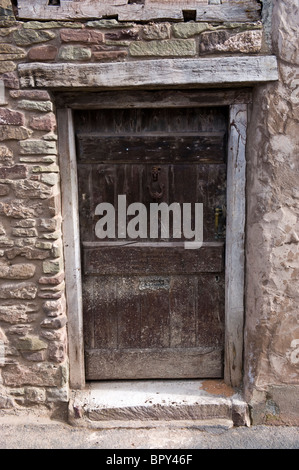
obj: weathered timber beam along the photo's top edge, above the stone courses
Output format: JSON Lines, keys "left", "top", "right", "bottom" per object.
{"left": 18, "top": 0, "right": 261, "bottom": 22}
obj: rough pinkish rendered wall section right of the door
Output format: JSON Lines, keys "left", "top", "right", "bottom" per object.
{"left": 244, "top": 0, "right": 299, "bottom": 423}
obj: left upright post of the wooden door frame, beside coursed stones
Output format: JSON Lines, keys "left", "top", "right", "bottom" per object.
{"left": 57, "top": 109, "right": 85, "bottom": 389}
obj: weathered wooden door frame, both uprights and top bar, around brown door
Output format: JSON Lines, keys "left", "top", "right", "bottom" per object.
{"left": 56, "top": 89, "right": 251, "bottom": 389}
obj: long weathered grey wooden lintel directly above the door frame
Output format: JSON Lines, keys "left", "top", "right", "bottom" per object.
{"left": 18, "top": 56, "right": 278, "bottom": 89}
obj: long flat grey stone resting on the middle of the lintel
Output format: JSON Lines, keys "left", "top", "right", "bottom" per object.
{"left": 129, "top": 39, "right": 196, "bottom": 57}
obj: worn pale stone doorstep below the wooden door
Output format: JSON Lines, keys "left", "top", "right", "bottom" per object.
{"left": 68, "top": 380, "right": 250, "bottom": 429}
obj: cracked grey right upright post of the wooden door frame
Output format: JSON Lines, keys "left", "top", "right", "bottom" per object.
{"left": 224, "top": 104, "right": 247, "bottom": 387}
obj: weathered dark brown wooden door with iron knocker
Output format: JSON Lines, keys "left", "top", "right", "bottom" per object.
{"left": 74, "top": 107, "right": 227, "bottom": 380}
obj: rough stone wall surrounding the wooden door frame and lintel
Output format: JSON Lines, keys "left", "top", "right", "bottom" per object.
{"left": 0, "top": 0, "right": 299, "bottom": 422}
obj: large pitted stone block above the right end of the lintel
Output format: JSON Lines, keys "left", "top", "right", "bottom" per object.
{"left": 199, "top": 30, "right": 262, "bottom": 54}
